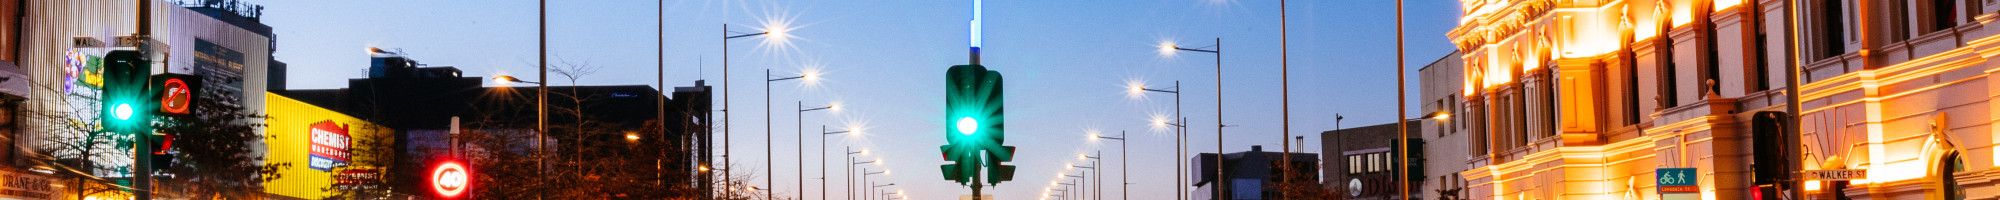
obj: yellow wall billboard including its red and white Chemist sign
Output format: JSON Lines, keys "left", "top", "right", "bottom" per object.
{"left": 264, "top": 92, "right": 394, "bottom": 200}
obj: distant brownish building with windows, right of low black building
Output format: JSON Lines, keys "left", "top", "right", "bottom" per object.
{"left": 1320, "top": 120, "right": 1430, "bottom": 200}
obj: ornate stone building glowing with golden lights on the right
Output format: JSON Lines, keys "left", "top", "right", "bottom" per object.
{"left": 1456, "top": 0, "right": 2000, "bottom": 200}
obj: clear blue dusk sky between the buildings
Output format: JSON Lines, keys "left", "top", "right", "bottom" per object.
{"left": 258, "top": 0, "right": 1460, "bottom": 200}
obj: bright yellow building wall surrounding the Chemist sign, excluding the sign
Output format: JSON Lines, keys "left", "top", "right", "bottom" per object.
{"left": 264, "top": 92, "right": 394, "bottom": 200}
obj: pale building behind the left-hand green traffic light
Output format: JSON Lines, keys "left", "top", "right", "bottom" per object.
{"left": 18, "top": 0, "right": 282, "bottom": 198}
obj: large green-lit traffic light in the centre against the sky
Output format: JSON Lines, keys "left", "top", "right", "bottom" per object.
{"left": 938, "top": 64, "right": 1014, "bottom": 184}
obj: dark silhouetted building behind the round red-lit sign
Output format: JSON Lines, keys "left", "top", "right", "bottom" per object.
{"left": 280, "top": 50, "right": 712, "bottom": 198}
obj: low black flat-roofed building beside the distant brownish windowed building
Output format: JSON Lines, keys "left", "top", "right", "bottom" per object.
{"left": 1188, "top": 146, "right": 1320, "bottom": 200}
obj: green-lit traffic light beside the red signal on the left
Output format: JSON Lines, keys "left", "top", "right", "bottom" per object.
{"left": 98, "top": 50, "right": 152, "bottom": 134}
